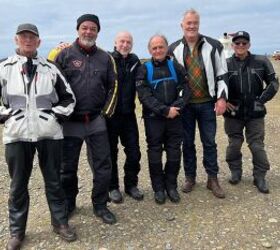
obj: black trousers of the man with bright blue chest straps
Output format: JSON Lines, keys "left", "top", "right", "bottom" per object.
{"left": 144, "top": 117, "right": 183, "bottom": 192}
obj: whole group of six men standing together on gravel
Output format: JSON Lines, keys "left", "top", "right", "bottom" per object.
{"left": 0, "top": 9, "right": 279, "bottom": 249}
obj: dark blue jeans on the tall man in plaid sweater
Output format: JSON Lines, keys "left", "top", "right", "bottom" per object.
{"left": 182, "top": 101, "right": 219, "bottom": 180}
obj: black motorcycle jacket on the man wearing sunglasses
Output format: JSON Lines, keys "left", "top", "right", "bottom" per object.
{"left": 224, "top": 53, "right": 279, "bottom": 119}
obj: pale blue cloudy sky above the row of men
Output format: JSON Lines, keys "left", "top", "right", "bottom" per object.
{"left": 0, "top": 0, "right": 280, "bottom": 58}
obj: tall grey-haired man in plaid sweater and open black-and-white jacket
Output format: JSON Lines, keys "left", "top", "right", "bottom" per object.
{"left": 169, "top": 9, "right": 228, "bottom": 198}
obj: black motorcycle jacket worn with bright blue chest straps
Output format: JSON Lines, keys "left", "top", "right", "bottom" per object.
{"left": 136, "top": 58, "right": 190, "bottom": 118}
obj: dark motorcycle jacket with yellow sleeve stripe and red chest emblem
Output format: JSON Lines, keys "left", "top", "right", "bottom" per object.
{"left": 55, "top": 40, "right": 118, "bottom": 119}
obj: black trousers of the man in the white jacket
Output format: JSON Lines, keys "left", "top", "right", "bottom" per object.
{"left": 5, "top": 140, "right": 68, "bottom": 238}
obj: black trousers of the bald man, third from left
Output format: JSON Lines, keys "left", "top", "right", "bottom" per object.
{"left": 107, "top": 113, "right": 141, "bottom": 190}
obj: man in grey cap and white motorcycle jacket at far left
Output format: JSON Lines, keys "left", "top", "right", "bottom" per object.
{"left": 0, "top": 24, "right": 76, "bottom": 250}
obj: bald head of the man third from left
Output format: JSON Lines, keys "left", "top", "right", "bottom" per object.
{"left": 115, "top": 31, "right": 133, "bottom": 57}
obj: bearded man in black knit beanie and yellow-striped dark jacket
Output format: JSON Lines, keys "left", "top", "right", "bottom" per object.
{"left": 55, "top": 14, "right": 117, "bottom": 224}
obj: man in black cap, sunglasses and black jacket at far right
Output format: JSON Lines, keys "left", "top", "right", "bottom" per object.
{"left": 224, "top": 31, "right": 279, "bottom": 193}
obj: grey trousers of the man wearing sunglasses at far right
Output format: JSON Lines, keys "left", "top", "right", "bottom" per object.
{"left": 224, "top": 117, "right": 270, "bottom": 176}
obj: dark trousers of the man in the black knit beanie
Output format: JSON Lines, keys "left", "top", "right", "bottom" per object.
{"left": 61, "top": 130, "right": 111, "bottom": 210}
